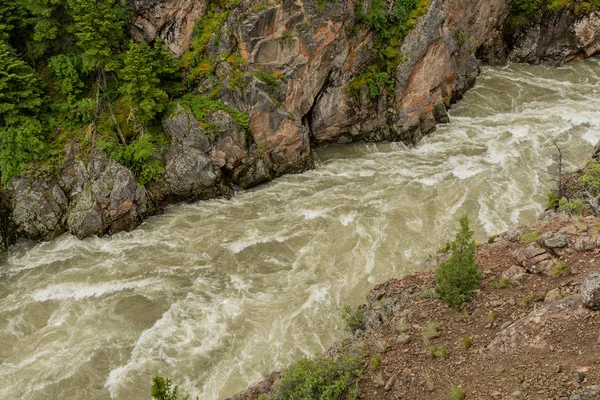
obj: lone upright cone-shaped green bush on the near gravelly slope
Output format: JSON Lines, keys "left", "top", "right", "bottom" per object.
{"left": 435, "top": 215, "right": 481, "bottom": 307}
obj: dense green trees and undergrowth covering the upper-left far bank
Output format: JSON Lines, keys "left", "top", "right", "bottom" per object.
{"left": 0, "top": 0, "right": 249, "bottom": 184}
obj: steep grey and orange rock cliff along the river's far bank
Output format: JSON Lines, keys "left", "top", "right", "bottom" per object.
{"left": 3, "top": 0, "right": 600, "bottom": 248}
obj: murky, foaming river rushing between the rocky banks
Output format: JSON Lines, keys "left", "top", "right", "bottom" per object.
{"left": 0, "top": 60, "right": 600, "bottom": 400}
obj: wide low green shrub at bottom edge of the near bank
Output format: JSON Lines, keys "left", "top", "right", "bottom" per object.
{"left": 267, "top": 354, "right": 362, "bottom": 400}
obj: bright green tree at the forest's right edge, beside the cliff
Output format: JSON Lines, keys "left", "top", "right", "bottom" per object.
{"left": 119, "top": 40, "right": 177, "bottom": 129}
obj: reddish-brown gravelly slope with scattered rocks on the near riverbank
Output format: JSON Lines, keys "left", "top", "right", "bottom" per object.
{"left": 234, "top": 212, "right": 600, "bottom": 400}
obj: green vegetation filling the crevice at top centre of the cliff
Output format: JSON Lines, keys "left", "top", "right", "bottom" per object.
{"left": 348, "top": 0, "right": 429, "bottom": 100}
